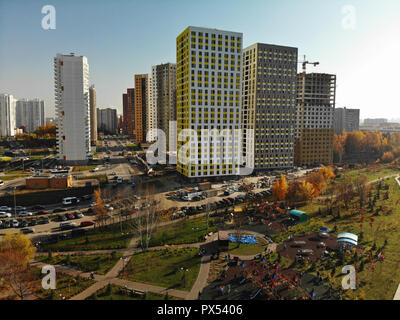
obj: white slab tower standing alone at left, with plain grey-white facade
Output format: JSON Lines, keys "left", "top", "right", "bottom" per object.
{"left": 54, "top": 54, "right": 90, "bottom": 162}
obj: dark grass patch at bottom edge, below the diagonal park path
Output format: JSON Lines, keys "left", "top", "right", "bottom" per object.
{"left": 86, "top": 284, "right": 180, "bottom": 300}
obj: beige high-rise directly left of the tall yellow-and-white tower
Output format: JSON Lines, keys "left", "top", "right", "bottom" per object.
{"left": 152, "top": 63, "right": 176, "bottom": 151}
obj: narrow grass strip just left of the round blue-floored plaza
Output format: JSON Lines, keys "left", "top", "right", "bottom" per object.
{"left": 150, "top": 217, "right": 218, "bottom": 247}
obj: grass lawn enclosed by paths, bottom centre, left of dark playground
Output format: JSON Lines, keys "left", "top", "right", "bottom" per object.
{"left": 121, "top": 248, "right": 201, "bottom": 291}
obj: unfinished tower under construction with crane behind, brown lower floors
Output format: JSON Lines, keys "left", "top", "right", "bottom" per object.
{"left": 295, "top": 72, "right": 336, "bottom": 166}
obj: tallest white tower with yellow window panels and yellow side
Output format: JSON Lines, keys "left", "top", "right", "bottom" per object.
{"left": 176, "top": 27, "right": 243, "bottom": 178}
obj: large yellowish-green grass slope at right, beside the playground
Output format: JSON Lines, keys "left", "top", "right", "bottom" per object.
{"left": 273, "top": 178, "right": 400, "bottom": 300}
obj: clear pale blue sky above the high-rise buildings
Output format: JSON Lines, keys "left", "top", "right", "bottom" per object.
{"left": 0, "top": 0, "right": 400, "bottom": 119}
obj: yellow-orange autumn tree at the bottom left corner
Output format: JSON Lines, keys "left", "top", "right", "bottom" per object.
{"left": 0, "top": 233, "right": 36, "bottom": 300}
